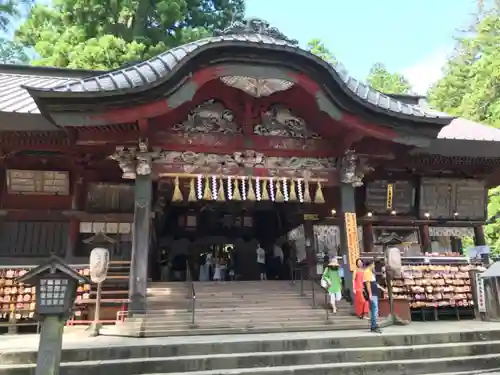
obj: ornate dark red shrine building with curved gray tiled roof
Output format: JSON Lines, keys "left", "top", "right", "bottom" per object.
{"left": 0, "top": 20, "right": 500, "bottom": 332}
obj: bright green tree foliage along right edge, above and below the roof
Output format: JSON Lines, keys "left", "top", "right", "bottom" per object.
{"left": 428, "top": 6, "right": 500, "bottom": 254}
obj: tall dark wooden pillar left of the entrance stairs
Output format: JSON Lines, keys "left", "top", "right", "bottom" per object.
{"left": 129, "top": 173, "right": 153, "bottom": 315}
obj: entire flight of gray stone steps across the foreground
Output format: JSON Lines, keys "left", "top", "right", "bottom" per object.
{"left": 0, "top": 323, "right": 500, "bottom": 375}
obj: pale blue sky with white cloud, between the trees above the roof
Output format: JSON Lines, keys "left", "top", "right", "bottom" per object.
{"left": 246, "top": 0, "right": 476, "bottom": 91}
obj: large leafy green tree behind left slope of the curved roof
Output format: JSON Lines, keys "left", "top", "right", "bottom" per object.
{"left": 16, "top": 0, "right": 244, "bottom": 69}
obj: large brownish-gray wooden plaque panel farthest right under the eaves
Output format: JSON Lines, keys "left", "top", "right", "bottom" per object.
{"left": 419, "top": 178, "right": 486, "bottom": 220}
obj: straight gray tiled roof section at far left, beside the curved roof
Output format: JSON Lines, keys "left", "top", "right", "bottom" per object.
{"left": 0, "top": 73, "right": 74, "bottom": 114}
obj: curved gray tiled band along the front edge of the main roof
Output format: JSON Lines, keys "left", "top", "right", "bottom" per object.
{"left": 27, "top": 34, "right": 452, "bottom": 119}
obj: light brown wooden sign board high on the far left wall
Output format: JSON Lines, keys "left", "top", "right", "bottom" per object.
{"left": 7, "top": 169, "right": 69, "bottom": 195}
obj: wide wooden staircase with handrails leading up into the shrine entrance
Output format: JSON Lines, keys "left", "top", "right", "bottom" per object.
{"left": 120, "top": 281, "right": 368, "bottom": 337}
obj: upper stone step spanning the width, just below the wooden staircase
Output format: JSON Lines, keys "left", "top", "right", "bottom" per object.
{"left": 0, "top": 330, "right": 500, "bottom": 366}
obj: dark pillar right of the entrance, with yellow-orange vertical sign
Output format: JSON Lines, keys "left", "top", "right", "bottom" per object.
{"left": 339, "top": 183, "right": 360, "bottom": 298}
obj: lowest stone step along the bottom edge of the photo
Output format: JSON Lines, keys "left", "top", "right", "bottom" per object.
{"left": 0, "top": 341, "right": 500, "bottom": 375}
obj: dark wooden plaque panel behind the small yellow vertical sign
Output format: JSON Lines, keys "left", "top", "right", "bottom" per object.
{"left": 366, "top": 180, "right": 415, "bottom": 214}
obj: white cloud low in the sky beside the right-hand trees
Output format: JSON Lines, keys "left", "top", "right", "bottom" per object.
{"left": 401, "top": 48, "right": 451, "bottom": 95}
